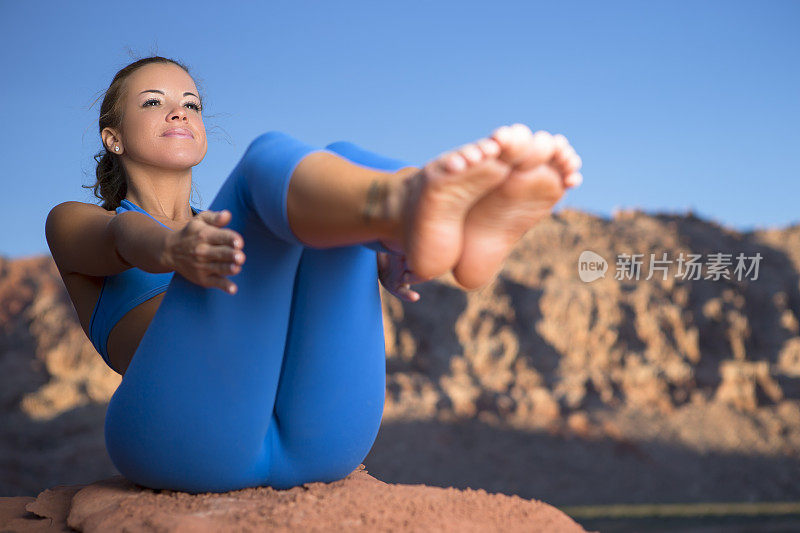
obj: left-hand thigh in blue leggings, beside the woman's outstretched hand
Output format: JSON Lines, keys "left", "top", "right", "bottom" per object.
{"left": 106, "top": 155, "right": 303, "bottom": 490}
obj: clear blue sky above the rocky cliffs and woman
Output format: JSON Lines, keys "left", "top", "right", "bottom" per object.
{"left": 0, "top": 0, "right": 800, "bottom": 257}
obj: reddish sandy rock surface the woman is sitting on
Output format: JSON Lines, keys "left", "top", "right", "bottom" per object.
{"left": 0, "top": 465, "right": 585, "bottom": 533}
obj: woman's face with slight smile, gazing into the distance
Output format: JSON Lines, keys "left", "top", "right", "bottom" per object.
{"left": 110, "top": 63, "right": 208, "bottom": 170}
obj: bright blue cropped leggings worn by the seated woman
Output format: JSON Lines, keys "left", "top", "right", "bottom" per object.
{"left": 105, "top": 131, "right": 411, "bottom": 493}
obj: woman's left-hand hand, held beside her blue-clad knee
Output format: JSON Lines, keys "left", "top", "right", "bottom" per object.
{"left": 164, "top": 209, "right": 245, "bottom": 294}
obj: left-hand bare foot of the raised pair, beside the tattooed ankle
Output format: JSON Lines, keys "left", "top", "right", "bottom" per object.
{"left": 384, "top": 138, "right": 510, "bottom": 279}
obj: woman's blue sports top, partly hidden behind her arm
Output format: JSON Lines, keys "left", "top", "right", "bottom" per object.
{"left": 89, "top": 199, "right": 198, "bottom": 369}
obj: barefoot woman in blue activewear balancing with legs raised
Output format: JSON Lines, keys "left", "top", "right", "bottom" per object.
{"left": 46, "top": 57, "right": 581, "bottom": 492}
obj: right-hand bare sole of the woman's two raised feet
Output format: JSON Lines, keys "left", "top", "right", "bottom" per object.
{"left": 453, "top": 124, "right": 583, "bottom": 290}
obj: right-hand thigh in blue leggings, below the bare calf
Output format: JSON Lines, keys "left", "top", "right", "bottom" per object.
{"left": 270, "top": 246, "right": 386, "bottom": 481}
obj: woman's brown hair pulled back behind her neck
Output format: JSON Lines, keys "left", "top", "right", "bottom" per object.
{"left": 81, "top": 56, "right": 202, "bottom": 211}
